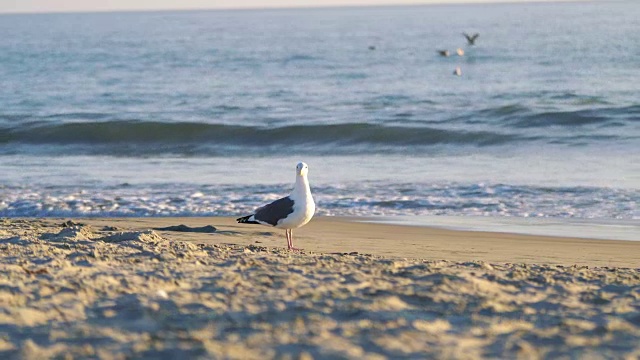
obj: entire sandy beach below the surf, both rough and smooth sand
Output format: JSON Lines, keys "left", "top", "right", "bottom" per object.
{"left": 0, "top": 218, "right": 640, "bottom": 359}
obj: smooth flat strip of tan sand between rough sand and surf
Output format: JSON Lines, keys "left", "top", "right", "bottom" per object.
{"left": 65, "top": 216, "right": 640, "bottom": 268}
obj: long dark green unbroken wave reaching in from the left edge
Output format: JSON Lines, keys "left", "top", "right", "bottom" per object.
{"left": 0, "top": 121, "right": 527, "bottom": 147}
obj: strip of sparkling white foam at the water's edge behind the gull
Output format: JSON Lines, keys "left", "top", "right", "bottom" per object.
{"left": 0, "top": 182, "right": 640, "bottom": 219}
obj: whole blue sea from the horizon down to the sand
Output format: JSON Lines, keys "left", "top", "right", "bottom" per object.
{"left": 0, "top": 2, "right": 640, "bottom": 220}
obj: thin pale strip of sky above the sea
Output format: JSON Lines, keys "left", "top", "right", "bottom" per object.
{"left": 0, "top": 0, "right": 564, "bottom": 13}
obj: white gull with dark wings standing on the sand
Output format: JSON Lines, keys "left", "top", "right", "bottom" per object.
{"left": 236, "top": 162, "right": 316, "bottom": 251}
